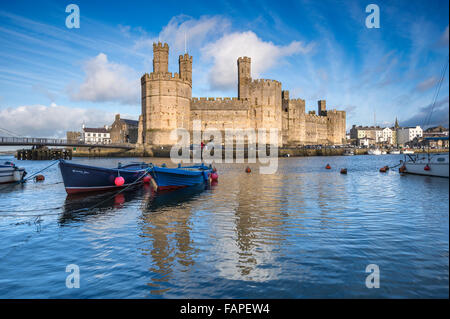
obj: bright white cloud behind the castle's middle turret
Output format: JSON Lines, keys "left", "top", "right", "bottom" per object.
{"left": 202, "top": 31, "right": 313, "bottom": 89}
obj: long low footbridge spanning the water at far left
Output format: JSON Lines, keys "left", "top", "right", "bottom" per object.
{"left": 0, "top": 136, "right": 134, "bottom": 150}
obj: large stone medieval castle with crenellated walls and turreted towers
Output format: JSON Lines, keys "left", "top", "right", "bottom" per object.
{"left": 138, "top": 42, "right": 346, "bottom": 146}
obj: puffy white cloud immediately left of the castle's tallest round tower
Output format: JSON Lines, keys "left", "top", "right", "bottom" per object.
{"left": 69, "top": 53, "right": 140, "bottom": 104}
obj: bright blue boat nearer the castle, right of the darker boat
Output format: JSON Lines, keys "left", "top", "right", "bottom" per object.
{"left": 149, "top": 164, "right": 213, "bottom": 190}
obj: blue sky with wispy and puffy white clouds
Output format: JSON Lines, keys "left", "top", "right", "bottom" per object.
{"left": 0, "top": 0, "right": 449, "bottom": 137}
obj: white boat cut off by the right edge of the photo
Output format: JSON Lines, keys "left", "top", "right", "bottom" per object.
{"left": 399, "top": 154, "right": 449, "bottom": 178}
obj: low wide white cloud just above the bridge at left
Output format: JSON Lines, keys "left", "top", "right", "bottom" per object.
{"left": 0, "top": 103, "right": 114, "bottom": 138}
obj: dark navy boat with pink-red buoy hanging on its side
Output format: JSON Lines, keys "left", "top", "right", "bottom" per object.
{"left": 59, "top": 160, "right": 150, "bottom": 194}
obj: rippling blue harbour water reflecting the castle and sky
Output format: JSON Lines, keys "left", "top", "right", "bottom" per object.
{"left": 0, "top": 155, "right": 449, "bottom": 298}
